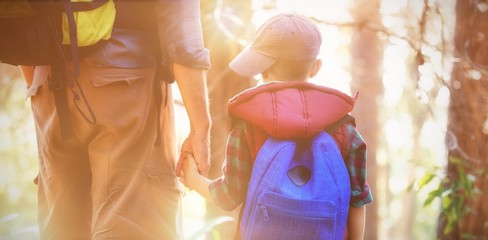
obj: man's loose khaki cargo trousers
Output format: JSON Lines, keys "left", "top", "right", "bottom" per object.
{"left": 32, "top": 64, "right": 181, "bottom": 240}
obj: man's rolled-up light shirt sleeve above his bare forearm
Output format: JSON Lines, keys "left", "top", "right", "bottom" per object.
{"left": 155, "top": 0, "right": 210, "bottom": 69}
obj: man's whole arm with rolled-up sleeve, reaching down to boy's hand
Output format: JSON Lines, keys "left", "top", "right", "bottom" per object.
{"left": 154, "top": 0, "right": 211, "bottom": 176}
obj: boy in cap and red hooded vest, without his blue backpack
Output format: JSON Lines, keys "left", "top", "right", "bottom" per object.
{"left": 181, "top": 13, "right": 372, "bottom": 239}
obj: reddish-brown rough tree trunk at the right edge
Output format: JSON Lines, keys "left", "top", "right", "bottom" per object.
{"left": 438, "top": 0, "right": 488, "bottom": 239}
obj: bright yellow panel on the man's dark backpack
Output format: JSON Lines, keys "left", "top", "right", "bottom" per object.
{"left": 62, "top": 0, "right": 115, "bottom": 47}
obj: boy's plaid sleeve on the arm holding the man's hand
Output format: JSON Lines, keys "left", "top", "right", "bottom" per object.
{"left": 209, "top": 122, "right": 252, "bottom": 211}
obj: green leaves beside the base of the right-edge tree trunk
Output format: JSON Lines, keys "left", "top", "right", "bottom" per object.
{"left": 415, "top": 157, "right": 487, "bottom": 239}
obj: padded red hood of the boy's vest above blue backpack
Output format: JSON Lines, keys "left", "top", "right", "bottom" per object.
{"left": 228, "top": 82, "right": 357, "bottom": 159}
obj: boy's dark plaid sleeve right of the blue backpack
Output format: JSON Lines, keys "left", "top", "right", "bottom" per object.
{"left": 344, "top": 124, "right": 373, "bottom": 207}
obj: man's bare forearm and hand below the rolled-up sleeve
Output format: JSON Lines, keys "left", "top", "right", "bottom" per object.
{"left": 173, "top": 64, "right": 211, "bottom": 176}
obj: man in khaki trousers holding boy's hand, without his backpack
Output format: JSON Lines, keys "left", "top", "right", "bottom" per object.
{"left": 22, "top": 0, "right": 211, "bottom": 240}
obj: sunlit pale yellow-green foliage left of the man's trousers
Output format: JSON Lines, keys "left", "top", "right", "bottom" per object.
{"left": 0, "top": 64, "right": 38, "bottom": 240}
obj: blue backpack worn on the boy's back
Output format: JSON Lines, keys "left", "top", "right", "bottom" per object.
{"left": 241, "top": 131, "right": 351, "bottom": 240}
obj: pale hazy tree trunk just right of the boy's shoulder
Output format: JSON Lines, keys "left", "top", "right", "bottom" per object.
{"left": 351, "top": 0, "right": 383, "bottom": 240}
